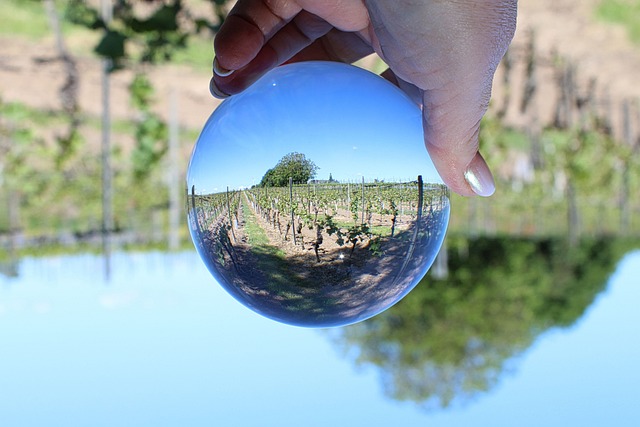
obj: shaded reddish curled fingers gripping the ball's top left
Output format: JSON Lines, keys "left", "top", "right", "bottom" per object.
{"left": 211, "top": 0, "right": 369, "bottom": 96}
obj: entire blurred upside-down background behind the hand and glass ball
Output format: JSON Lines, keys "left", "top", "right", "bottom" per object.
{"left": 0, "top": 0, "right": 640, "bottom": 426}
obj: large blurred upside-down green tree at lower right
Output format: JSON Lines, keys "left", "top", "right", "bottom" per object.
{"left": 333, "top": 237, "right": 628, "bottom": 408}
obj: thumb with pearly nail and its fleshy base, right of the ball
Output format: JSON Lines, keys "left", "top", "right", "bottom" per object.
{"left": 365, "top": 0, "right": 517, "bottom": 196}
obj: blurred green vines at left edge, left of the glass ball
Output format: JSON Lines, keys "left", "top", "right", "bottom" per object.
{"left": 0, "top": 102, "right": 178, "bottom": 238}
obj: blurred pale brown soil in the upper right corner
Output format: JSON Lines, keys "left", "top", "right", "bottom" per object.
{"left": 493, "top": 0, "right": 640, "bottom": 138}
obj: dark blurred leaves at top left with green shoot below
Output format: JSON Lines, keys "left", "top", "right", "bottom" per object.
{"left": 63, "top": 0, "right": 232, "bottom": 179}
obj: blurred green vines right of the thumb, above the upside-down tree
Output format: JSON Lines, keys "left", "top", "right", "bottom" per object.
{"left": 460, "top": 116, "right": 640, "bottom": 236}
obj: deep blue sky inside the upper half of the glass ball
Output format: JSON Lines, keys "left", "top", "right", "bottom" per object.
{"left": 187, "top": 63, "right": 441, "bottom": 193}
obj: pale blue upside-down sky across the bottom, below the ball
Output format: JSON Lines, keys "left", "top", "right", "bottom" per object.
{"left": 0, "top": 252, "right": 640, "bottom": 427}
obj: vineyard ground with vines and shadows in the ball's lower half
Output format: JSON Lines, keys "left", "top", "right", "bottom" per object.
{"left": 188, "top": 177, "right": 449, "bottom": 326}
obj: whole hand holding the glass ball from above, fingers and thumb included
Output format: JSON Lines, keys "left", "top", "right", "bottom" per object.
{"left": 212, "top": 0, "right": 517, "bottom": 196}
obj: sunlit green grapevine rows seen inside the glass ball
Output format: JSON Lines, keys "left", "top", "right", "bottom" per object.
{"left": 244, "top": 177, "right": 446, "bottom": 261}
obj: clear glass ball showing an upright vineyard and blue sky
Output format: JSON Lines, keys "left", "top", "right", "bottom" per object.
{"left": 187, "top": 62, "right": 450, "bottom": 327}
